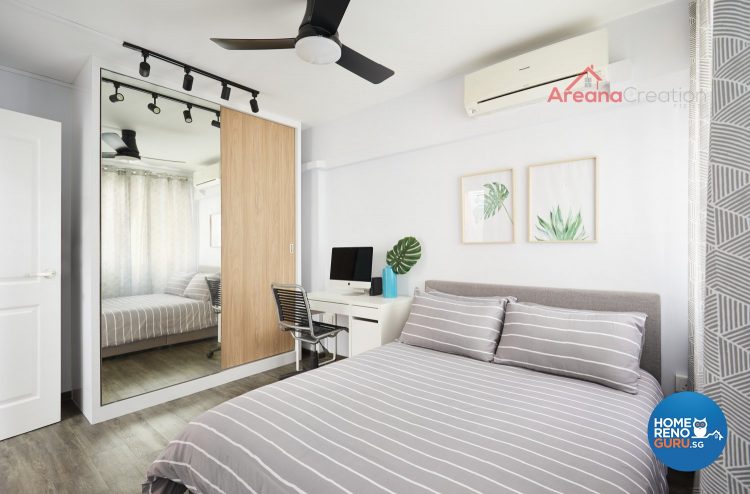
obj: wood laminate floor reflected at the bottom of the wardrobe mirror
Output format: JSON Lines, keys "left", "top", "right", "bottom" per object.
{"left": 101, "top": 338, "right": 221, "bottom": 403}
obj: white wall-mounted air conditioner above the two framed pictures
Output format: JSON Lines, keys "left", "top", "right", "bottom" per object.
{"left": 464, "top": 29, "right": 609, "bottom": 116}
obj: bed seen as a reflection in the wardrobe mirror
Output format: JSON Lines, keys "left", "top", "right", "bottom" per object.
{"left": 101, "top": 293, "right": 218, "bottom": 358}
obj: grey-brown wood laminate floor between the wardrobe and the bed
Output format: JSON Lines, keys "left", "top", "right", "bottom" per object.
{"left": 0, "top": 352, "right": 704, "bottom": 494}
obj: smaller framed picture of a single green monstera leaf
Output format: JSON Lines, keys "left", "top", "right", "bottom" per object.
{"left": 461, "top": 168, "right": 516, "bottom": 244}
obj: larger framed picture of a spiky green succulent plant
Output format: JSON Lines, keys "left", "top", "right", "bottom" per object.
{"left": 529, "top": 157, "right": 599, "bottom": 242}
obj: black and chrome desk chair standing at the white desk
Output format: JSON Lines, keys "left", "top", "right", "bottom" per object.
{"left": 271, "top": 284, "right": 347, "bottom": 368}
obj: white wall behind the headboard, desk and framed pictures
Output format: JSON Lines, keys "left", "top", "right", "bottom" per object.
{"left": 303, "top": 2, "right": 689, "bottom": 392}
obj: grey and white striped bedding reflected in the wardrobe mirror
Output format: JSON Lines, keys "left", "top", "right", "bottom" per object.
{"left": 101, "top": 293, "right": 218, "bottom": 348}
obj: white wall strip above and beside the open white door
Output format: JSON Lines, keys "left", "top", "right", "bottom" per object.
{"left": 0, "top": 66, "right": 74, "bottom": 391}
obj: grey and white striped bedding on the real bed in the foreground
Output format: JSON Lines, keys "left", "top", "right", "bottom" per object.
{"left": 143, "top": 343, "right": 667, "bottom": 494}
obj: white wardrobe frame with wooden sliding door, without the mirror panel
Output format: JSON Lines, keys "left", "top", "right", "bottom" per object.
{"left": 71, "top": 59, "right": 301, "bottom": 423}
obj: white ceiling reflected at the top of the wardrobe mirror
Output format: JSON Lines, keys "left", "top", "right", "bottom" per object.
{"left": 101, "top": 68, "right": 221, "bottom": 171}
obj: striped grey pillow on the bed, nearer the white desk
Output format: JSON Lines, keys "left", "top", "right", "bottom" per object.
{"left": 399, "top": 289, "right": 508, "bottom": 362}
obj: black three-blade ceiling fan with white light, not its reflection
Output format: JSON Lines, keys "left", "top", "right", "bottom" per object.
{"left": 211, "top": 0, "right": 394, "bottom": 84}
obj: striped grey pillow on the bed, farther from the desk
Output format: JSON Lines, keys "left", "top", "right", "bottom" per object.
{"left": 493, "top": 303, "right": 646, "bottom": 394}
